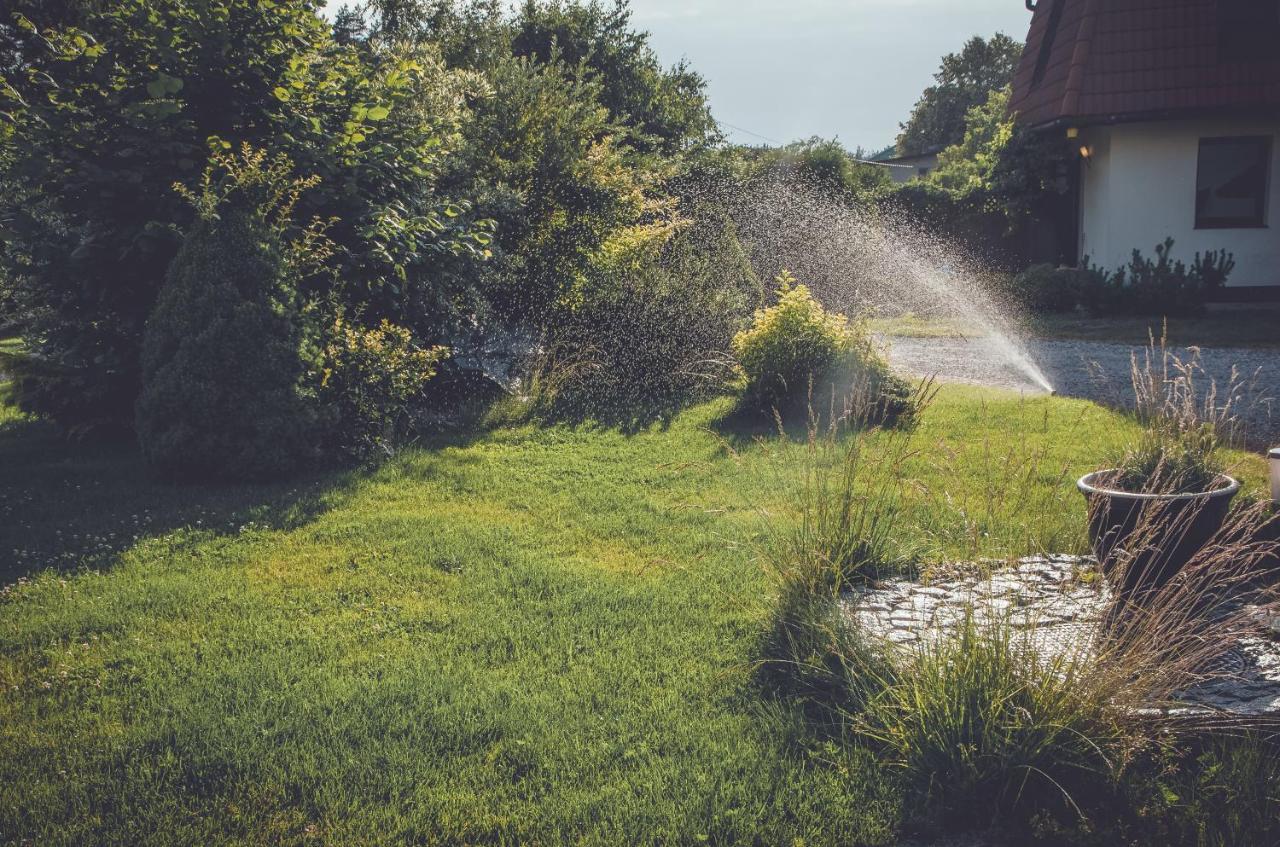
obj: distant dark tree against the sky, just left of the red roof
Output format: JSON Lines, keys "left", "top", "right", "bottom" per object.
{"left": 897, "top": 32, "right": 1023, "bottom": 156}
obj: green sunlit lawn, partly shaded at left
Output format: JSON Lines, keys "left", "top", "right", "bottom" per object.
{"left": 0, "top": 386, "right": 1265, "bottom": 844}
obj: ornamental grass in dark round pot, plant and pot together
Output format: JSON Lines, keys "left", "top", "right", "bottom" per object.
{"left": 1078, "top": 343, "right": 1240, "bottom": 603}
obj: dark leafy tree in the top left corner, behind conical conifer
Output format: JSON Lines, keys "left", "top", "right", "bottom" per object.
{"left": 0, "top": 0, "right": 326, "bottom": 430}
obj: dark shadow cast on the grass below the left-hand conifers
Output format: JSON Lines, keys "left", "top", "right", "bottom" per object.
{"left": 0, "top": 409, "right": 366, "bottom": 585}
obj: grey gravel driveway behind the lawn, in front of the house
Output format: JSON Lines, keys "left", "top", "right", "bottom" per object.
{"left": 888, "top": 338, "right": 1280, "bottom": 443}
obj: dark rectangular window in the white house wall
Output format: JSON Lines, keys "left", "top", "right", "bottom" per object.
{"left": 1196, "top": 136, "right": 1271, "bottom": 229}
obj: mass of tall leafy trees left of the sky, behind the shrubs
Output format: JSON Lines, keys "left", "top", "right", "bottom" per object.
{"left": 0, "top": 0, "right": 739, "bottom": 431}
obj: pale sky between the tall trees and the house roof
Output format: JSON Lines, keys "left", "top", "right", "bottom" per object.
{"left": 329, "top": 0, "right": 1030, "bottom": 151}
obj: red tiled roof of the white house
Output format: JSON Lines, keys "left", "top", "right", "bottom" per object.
{"left": 1011, "top": 0, "right": 1280, "bottom": 125}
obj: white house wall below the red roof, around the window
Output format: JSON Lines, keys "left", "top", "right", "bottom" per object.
{"left": 1079, "top": 119, "right": 1280, "bottom": 287}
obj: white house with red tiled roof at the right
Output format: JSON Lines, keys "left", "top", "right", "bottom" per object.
{"left": 1011, "top": 0, "right": 1280, "bottom": 301}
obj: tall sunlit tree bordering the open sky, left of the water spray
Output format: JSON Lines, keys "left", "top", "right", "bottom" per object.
{"left": 378, "top": 0, "right": 717, "bottom": 342}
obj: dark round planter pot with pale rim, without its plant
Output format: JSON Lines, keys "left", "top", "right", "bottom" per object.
{"left": 1076, "top": 470, "right": 1240, "bottom": 601}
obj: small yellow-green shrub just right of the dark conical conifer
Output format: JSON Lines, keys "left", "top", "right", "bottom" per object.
{"left": 320, "top": 316, "right": 448, "bottom": 457}
